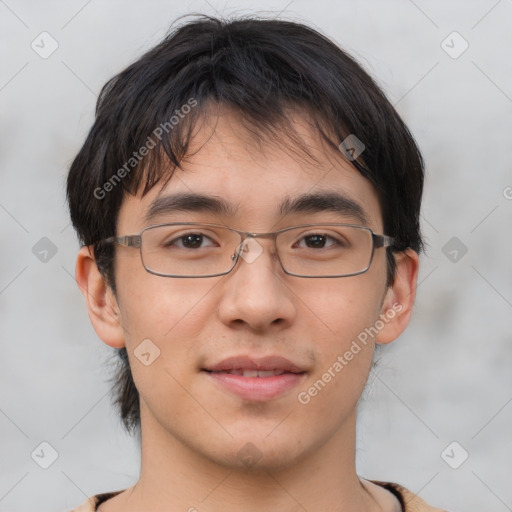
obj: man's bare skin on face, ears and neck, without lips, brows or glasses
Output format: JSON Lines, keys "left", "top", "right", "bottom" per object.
{"left": 76, "top": 109, "right": 418, "bottom": 512}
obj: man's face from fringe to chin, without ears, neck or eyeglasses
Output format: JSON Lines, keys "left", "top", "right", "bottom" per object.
{"left": 111, "top": 113, "right": 392, "bottom": 468}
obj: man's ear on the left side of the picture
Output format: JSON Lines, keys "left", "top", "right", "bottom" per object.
{"left": 75, "top": 246, "right": 125, "bottom": 348}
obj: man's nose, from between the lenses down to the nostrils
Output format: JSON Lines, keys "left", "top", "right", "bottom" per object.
{"left": 218, "top": 238, "right": 296, "bottom": 332}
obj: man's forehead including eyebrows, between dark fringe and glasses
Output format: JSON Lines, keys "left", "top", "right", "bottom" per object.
{"left": 118, "top": 109, "right": 382, "bottom": 233}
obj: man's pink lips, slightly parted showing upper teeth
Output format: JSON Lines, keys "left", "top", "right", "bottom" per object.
{"left": 202, "top": 356, "right": 307, "bottom": 402}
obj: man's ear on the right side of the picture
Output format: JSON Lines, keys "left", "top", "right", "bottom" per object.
{"left": 375, "top": 249, "right": 419, "bottom": 344}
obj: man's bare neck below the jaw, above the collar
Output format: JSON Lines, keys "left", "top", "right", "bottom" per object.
{"left": 118, "top": 407, "right": 379, "bottom": 512}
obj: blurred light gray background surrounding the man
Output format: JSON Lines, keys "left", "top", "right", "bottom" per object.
{"left": 0, "top": 0, "right": 512, "bottom": 512}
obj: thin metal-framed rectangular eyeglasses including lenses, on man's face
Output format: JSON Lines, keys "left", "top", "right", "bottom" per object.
{"left": 100, "top": 222, "right": 394, "bottom": 277}
